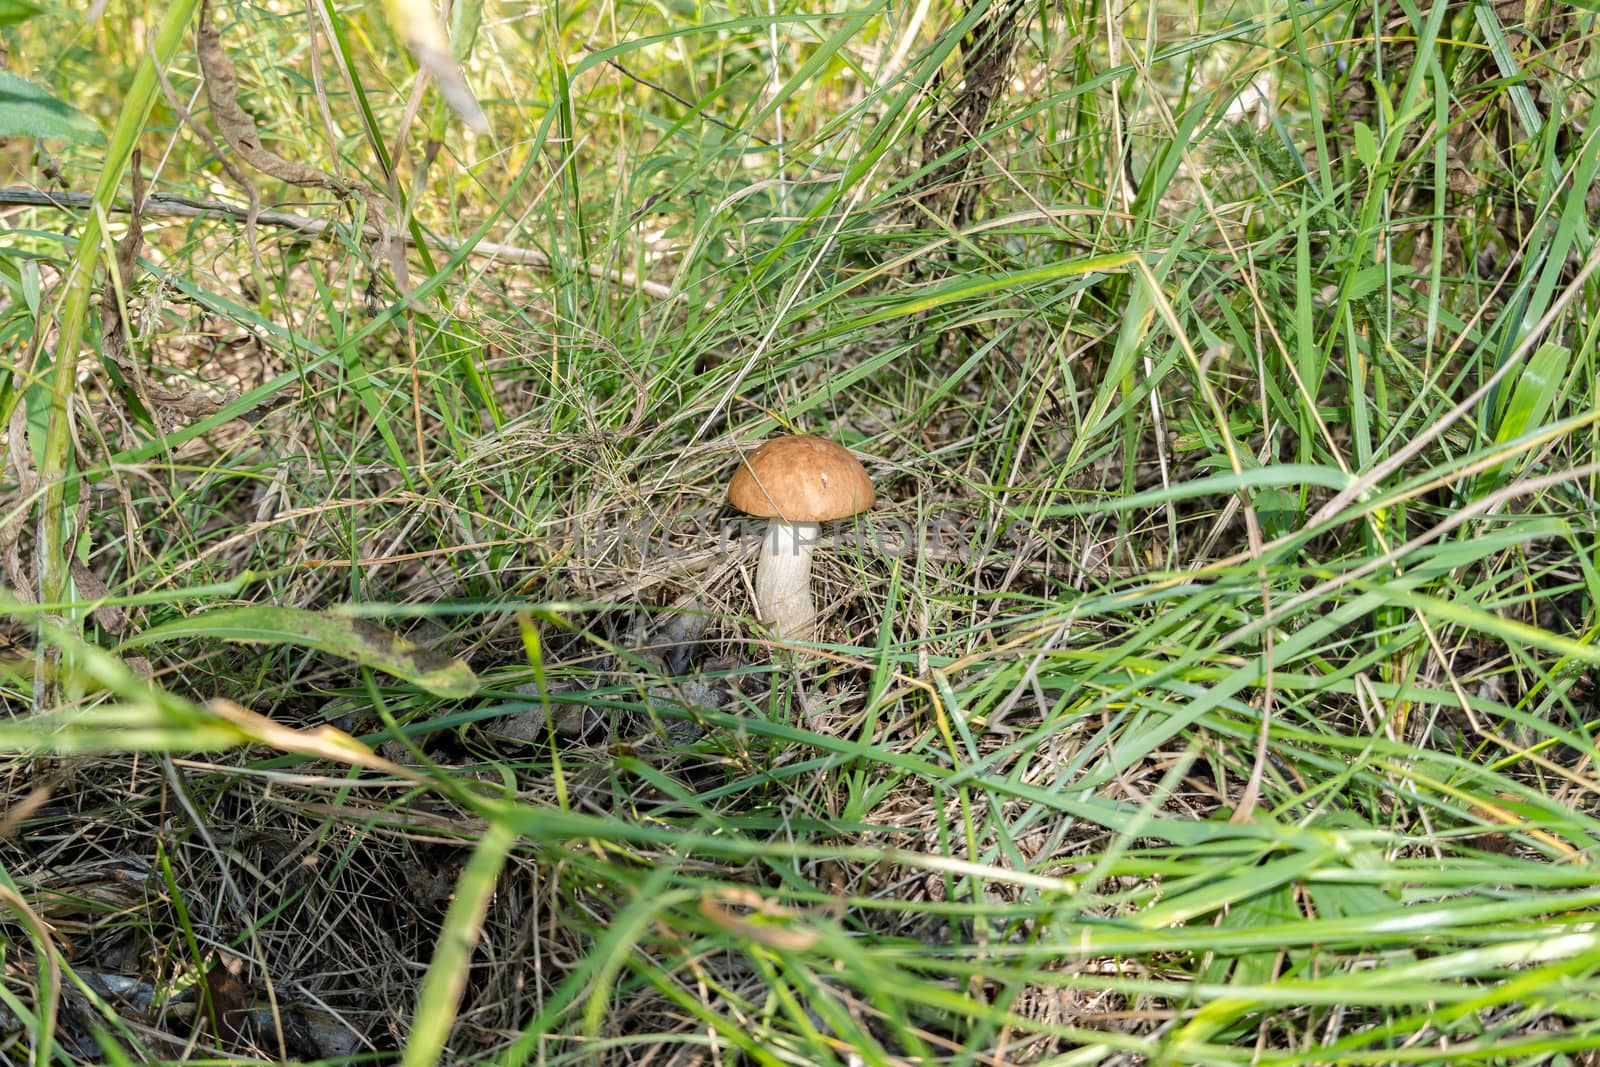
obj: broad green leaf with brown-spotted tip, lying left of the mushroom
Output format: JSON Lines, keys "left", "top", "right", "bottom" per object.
{"left": 122, "top": 605, "right": 478, "bottom": 697}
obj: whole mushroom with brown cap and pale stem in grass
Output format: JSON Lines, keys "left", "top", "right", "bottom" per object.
{"left": 728, "top": 435, "right": 877, "bottom": 641}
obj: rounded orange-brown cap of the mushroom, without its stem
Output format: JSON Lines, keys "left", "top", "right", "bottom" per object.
{"left": 728, "top": 435, "right": 878, "bottom": 523}
